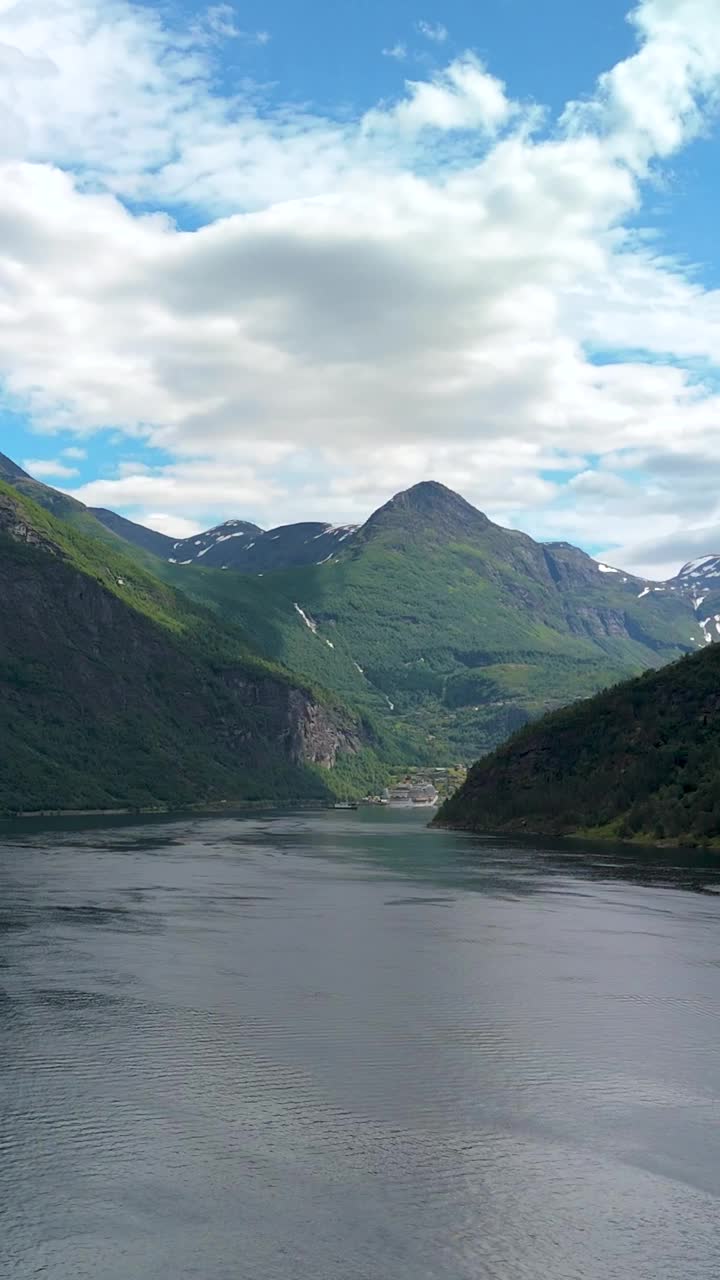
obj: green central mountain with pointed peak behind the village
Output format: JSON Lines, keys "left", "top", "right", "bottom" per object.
{"left": 152, "top": 483, "right": 700, "bottom": 763}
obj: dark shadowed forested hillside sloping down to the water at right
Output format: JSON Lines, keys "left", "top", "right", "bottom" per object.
{"left": 437, "top": 645, "right": 720, "bottom": 842}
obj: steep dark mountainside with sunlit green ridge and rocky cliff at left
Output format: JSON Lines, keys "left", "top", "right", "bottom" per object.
{"left": 0, "top": 476, "right": 374, "bottom": 812}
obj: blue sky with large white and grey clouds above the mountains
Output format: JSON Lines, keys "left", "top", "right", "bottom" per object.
{"left": 0, "top": 0, "right": 720, "bottom": 573}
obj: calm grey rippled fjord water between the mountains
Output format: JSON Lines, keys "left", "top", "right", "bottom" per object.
{"left": 0, "top": 810, "right": 720, "bottom": 1280}
